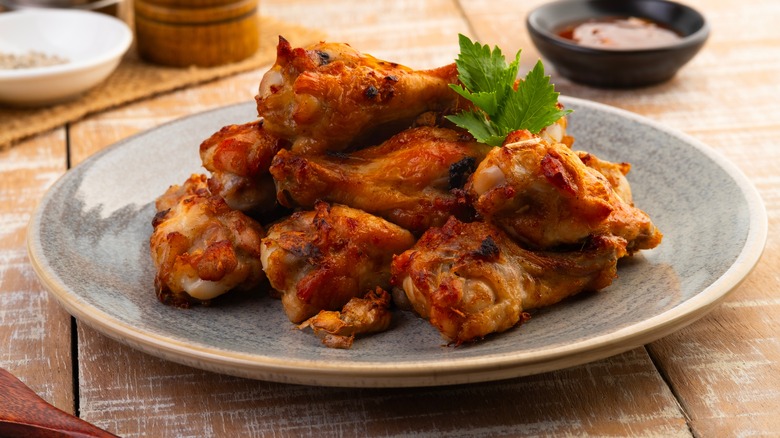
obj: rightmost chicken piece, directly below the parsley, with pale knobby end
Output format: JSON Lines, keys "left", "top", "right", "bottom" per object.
{"left": 466, "top": 131, "right": 662, "bottom": 252}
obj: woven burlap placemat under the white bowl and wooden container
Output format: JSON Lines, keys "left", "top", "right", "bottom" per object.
{"left": 0, "top": 17, "right": 323, "bottom": 151}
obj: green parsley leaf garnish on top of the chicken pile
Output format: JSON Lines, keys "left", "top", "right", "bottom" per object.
{"left": 447, "top": 35, "right": 571, "bottom": 146}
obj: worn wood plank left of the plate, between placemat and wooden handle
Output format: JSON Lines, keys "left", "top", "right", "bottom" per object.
{"left": 0, "top": 129, "right": 74, "bottom": 412}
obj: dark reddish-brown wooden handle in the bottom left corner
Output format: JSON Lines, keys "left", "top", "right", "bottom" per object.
{"left": 0, "top": 368, "right": 116, "bottom": 438}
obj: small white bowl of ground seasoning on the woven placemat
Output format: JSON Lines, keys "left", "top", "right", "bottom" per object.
{"left": 0, "top": 9, "right": 133, "bottom": 107}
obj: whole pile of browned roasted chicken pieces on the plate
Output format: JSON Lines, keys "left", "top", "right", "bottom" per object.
{"left": 150, "top": 38, "right": 662, "bottom": 348}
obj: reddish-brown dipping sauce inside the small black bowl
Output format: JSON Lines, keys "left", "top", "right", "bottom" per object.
{"left": 558, "top": 17, "right": 682, "bottom": 50}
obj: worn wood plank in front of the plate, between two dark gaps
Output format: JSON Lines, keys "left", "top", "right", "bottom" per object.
{"left": 79, "top": 326, "right": 690, "bottom": 438}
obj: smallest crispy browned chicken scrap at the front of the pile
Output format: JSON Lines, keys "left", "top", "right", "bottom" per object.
{"left": 298, "top": 287, "right": 392, "bottom": 349}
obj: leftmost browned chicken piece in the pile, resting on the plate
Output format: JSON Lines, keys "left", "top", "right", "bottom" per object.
{"left": 149, "top": 175, "right": 265, "bottom": 307}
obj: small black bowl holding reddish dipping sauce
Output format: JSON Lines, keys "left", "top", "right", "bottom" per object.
{"left": 526, "top": 0, "right": 710, "bottom": 88}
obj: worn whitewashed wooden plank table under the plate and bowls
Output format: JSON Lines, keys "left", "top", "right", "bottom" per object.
{"left": 0, "top": 0, "right": 780, "bottom": 437}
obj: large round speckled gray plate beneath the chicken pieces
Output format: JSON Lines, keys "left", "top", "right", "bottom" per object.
{"left": 28, "top": 98, "right": 767, "bottom": 387}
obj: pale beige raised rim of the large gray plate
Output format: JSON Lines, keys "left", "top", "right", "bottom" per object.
{"left": 27, "top": 96, "right": 768, "bottom": 387}
